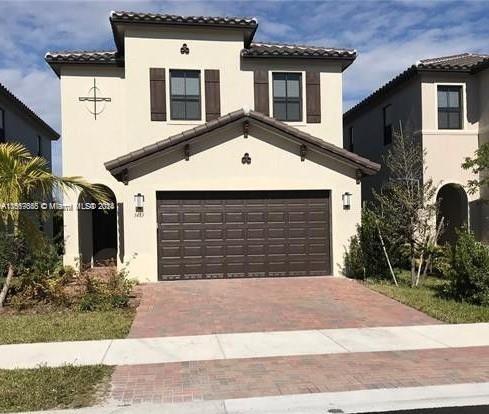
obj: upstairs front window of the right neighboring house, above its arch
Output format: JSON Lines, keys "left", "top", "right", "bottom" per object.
{"left": 438, "top": 86, "right": 462, "bottom": 129}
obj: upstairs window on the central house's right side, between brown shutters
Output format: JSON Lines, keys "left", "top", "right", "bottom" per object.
{"left": 273, "top": 73, "right": 302, "bottom": 121}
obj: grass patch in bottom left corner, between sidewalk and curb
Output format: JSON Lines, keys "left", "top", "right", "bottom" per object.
{"left": 0, "top": 365, "right": 112, "bottom": 413}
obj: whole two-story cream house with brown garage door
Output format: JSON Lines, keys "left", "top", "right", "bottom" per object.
{"left": 46, "top": 12, "right": 379, "bottom": 281}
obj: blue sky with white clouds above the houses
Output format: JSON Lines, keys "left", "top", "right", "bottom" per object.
{"left": 0, "top": 0, "right": 489, "bottom": 172}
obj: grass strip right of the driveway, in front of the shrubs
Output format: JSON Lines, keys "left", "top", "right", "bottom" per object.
{"left": 366, "top": 274, "right": 489, "bottom": 323}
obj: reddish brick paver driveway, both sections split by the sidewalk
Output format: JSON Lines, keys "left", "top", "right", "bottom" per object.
{"left": 111, "top": 277, "right": 450, "bottom": 403}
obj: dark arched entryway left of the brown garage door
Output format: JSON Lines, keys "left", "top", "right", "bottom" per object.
{"left": 78, "top": 186, "right": 117, "bottom": 267}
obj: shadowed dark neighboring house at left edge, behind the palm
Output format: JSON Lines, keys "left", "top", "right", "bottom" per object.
{"left": 0, "top": 83, "right": 59, "bottom": 235}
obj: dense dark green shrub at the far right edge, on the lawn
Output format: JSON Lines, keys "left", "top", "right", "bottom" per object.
{"left": 446, "top": 230, "right": 489, "bottom": 305}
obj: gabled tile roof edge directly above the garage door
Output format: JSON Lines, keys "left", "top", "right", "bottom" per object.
{"left": 105, "top": 109, "right": 380, "bottom": 180}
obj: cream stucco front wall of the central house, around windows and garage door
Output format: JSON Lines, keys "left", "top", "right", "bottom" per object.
{"left": 61, "top": 25, "right": 360, "bottom": 281}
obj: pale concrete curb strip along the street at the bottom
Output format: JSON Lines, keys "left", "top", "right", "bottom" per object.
{"left": 18, "top": 383, "right": 489, "bottom": 414}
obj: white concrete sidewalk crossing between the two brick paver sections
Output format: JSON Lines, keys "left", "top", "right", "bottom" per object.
{"left": 0, "top": 323, "right": 489, "bottom": 369}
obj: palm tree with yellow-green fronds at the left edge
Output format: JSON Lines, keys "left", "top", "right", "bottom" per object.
{"left": 0, "top": 142, "right": 108, "bottom": 309}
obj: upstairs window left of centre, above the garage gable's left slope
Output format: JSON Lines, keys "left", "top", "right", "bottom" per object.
{"left": 170, "top": 70, "right": 201, "bottom": 120}
